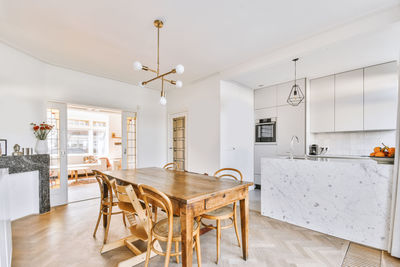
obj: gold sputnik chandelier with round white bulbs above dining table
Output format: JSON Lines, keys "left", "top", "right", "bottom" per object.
{"left": 133, "top": 19, "right": 185, "bottom": 105}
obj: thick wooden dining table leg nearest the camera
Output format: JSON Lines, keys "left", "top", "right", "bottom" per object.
{"left": 179, "top": 205, "right": 194, "bottom": 267}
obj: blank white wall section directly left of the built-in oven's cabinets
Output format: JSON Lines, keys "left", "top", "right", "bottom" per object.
{"left": 220, "top": 81, "right": 254, "bottom": 182}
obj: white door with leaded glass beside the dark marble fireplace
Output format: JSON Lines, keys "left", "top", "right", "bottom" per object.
{"left": 47, "top": 102, "right": 68, "bottom": 207}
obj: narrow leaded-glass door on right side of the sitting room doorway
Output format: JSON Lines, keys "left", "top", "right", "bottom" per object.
{"left": 121, "top": 111, "right": 136, "bottom": 169}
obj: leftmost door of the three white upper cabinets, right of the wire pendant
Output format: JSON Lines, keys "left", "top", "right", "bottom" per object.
{"left": 309, "top": 75, "right": 335, "bottom": 133}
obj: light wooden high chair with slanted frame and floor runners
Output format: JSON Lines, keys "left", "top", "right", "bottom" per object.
{"left": 101, "top": 183, "right": 162, "bottom": 267}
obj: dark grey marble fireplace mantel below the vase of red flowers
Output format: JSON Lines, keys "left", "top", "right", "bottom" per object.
{"left": 0, "top": 154, "right": 50, "bottom": 213}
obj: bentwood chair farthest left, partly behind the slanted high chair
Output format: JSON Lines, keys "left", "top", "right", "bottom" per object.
{"left": 93, "top": 170, "right": 126, "bottom": 244}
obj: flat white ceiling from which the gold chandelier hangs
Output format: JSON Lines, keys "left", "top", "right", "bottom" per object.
{"left": 0, "top": 0, "right": 399, "bottom": 90}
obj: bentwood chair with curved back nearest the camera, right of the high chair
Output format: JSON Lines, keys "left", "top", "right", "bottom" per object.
{"left": 139, "top": 185, "right": 201, "bottom": 267}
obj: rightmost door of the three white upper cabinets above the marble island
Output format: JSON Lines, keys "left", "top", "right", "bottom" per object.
{"left": 364, "top": 62, "right": 398, "bottom": 130}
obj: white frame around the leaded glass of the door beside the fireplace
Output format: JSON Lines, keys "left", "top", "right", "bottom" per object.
{"left": 46, "top": 101, "right": 68, "bottom": 207}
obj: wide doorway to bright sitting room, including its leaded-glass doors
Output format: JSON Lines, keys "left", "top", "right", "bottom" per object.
{"left": 47, "top": 104, "right": 136, "bottom": 205}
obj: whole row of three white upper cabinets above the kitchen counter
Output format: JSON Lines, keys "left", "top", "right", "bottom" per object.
{"left": 310, "top": 62, "right": 398, "bottom": 133}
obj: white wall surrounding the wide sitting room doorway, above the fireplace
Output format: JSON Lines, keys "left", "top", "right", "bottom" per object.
{"left": 0, "top": 44, "right": 166, "bottom": 167}
